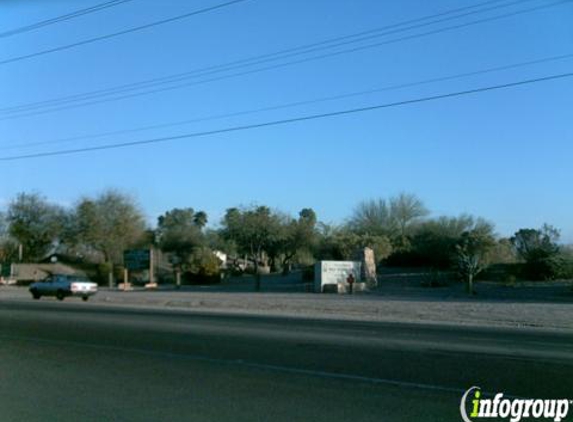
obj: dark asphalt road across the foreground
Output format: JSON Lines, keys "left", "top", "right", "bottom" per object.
{"left": 0, "top": 300, "right": 573, "bottom": 422}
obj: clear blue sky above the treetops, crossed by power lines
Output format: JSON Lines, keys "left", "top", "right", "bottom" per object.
{"left": 0, "top": 0, "right": 573, "bottom": 242}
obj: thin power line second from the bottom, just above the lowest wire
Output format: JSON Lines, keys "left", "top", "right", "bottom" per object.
{"left": 0, "top": 53, "right": 573, "bottom": 151}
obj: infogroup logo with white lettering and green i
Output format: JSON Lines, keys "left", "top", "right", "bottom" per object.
{"left": 460, "top": 387, "right": 573, "bottom": 422}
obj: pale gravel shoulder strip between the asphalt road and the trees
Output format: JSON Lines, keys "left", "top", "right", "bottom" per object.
{"left": 0, "top": 286, "right": 573, "bottom": 330}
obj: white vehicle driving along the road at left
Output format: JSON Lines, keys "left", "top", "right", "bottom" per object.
{"left": 30, "top": 274, "right": 97, "bottom": 301}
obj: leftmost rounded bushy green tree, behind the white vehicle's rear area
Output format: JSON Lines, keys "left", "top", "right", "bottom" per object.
{"left": 6, "top": 193, "right": 65, "bottom": 260}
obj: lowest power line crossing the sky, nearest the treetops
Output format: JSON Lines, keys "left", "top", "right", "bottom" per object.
{"left": 0, "top": 72, "right": 573, "bottom": 161}
